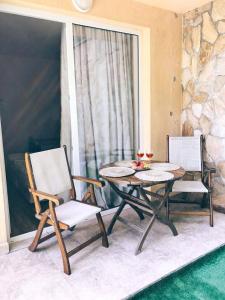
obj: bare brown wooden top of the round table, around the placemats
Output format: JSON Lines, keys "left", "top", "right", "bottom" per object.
{"left": 101, "top": 163, "right": 185, "bottom": 186}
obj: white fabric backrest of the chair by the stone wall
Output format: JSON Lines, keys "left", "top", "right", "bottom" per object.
{"left": 168, "top": 135, "right": 203, "bottom": 172}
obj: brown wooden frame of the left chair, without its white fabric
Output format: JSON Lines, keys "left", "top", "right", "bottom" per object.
{"left": 25, "top": 146, "right": 109, "bottom": 275}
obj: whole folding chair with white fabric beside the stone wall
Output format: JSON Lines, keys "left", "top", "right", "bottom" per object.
{"left": 167, "top": 135, "right": 215, "bottom": 226}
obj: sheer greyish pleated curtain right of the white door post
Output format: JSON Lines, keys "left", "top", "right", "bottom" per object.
{"left": 73, "top": 25, "right": 138, "bottom": 208}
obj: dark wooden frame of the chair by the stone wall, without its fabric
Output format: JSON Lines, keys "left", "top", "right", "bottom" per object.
{"left": 166, "top": 135, "right": 216, "bottom": 227}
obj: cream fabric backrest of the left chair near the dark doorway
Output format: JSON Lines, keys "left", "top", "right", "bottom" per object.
{"left": 26, "top": 147, "right": 74, "bottom": 213}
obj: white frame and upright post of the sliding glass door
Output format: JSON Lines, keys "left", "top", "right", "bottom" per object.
{"left": 0, "top": 4, "right": 151, "bottom": 250}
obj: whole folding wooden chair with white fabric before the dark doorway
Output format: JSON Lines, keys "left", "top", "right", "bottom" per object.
{"left": 25, "top": 147, "right": 108, "bottom": 275}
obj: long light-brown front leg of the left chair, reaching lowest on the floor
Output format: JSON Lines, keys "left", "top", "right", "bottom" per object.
{"left": 50, "top": 203, "right": 71, "bottom": 275}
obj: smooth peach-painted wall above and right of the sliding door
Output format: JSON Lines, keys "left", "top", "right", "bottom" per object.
{"left": 1, "top": 0, "right": 182, "bottom": 159}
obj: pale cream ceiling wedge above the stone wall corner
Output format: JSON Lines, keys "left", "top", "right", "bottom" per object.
{"left": 134, "top": 0, "right": 210, "bottom": 13}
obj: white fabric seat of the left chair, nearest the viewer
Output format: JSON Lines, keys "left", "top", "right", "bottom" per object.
{"left": 55, "top": 201, "right": 101, "bottom": 227}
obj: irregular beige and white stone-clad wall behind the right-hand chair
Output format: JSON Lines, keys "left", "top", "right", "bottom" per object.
{"left": 182, "top": 0, "right": 225, "bottom": 194}
